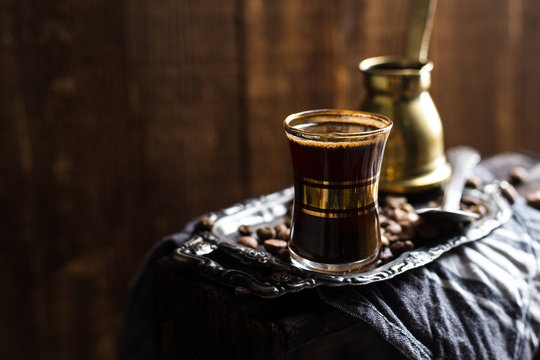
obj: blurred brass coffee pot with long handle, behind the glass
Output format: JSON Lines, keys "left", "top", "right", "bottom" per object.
{"left": 360, "top": 0, "right": 451, "bottom": 193}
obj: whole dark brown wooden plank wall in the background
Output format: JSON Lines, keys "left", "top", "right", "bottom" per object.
{"left": 0, "top": 0, "right": 540, "bottom": 359}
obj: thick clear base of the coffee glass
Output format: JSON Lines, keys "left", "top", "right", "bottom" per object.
{"left": 289, "top": 248, "right": 380, "bottom": 275}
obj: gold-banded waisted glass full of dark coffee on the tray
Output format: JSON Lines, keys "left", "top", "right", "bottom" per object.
{"left": 284, "top": 110, "right": 392, "bottom": 273}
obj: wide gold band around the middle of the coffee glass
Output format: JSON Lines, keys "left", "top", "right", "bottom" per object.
{"left": 297, "top": 176, "right": 377, "bottom": 218}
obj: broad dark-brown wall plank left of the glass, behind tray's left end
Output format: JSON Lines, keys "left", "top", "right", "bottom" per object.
{"left": 122, "top": 1, "right": 247, "bottom": 233}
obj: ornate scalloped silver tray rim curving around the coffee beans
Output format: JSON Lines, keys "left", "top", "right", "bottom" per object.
{"left": 174, "top": 184, "right": 512, "bottom": 298}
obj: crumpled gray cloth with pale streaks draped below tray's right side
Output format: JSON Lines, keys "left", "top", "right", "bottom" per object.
{"left": 319, "top": 199, "right": 540, "bottom": 359}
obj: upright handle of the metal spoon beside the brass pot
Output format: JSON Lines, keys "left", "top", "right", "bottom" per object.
{"left": 441, "top": 146, "right": 480, "bottom": 211}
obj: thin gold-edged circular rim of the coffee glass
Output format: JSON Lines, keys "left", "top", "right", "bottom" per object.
{"left": 283, "top": 109, "right": 393, "bottom": 141}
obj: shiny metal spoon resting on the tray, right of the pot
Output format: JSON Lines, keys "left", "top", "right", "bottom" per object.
{"left": 416, "top": 146, "right": 480, "bottom": 222}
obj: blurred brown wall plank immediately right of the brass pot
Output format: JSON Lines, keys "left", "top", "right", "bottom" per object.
{"left": 430, "top": 1, "right": 513, "bottom": 155}
